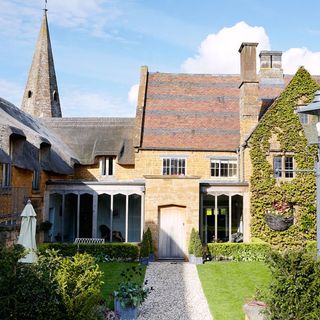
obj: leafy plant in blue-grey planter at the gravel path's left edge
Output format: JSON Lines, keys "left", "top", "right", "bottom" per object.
{"left": 114, "top": 266, "right": 153, "bottom": 320}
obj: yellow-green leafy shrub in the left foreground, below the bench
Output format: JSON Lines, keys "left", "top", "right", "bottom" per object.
{"left": 55, "top": 253, "right": 102, "bottom": 320}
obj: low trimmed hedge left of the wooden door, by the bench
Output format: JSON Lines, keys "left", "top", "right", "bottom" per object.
{"left": 38, "top": 242, "right": 139, "bottom": 261}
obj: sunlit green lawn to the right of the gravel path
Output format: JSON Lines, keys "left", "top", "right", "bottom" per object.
{"left": 198, "top": 262, "right": 271, "bottom": 320}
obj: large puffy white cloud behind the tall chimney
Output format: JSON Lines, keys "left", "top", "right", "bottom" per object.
{"left": 182, "top": 21, "right": 270, "bottom": 73}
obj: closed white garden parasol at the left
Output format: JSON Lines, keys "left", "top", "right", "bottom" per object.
{"left": 18, "top": 200, "right": 37, "bottom": 263}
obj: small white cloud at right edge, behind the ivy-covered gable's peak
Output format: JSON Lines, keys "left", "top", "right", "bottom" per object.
{"left": 282, "top": 48, "right": 320, "bottom": 74}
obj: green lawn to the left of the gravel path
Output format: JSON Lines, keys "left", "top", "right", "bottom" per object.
{"left": 99, "top": 262, "right": 146, "bottom": 309}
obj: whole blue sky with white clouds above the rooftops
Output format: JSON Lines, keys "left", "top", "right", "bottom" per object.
{"left": 0, "top": 0, "right": 320, "bottom": 116}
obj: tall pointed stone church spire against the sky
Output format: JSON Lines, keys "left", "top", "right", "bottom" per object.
{"left": 21, "top": 8, "right": 62, "bottom": 118}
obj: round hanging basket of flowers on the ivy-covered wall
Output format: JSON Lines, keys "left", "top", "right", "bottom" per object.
{"left": 265, "top": 201, "right": 294, "bottom": 231}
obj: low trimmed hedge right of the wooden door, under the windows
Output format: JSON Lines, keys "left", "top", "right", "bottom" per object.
{"left": 208, "top": 242, "right": 271, "bottom": 261}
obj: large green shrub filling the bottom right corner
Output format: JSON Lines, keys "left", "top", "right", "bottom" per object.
{"left": 264, "top": 251, "right": 320, "bottom": 320}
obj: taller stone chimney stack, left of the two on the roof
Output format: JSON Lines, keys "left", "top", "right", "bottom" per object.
{"left": 239, "top": 42, "right": 260, "bottom": 144}
